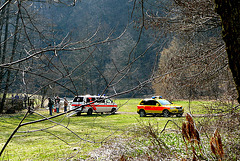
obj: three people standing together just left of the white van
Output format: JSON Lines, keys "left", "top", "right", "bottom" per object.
{"left": 48, "top": 96, "right": 69, "bottom": 116}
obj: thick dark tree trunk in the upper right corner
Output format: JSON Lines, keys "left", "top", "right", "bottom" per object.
{"left": 215, "top": 0, "right": 240, "bottom": 103}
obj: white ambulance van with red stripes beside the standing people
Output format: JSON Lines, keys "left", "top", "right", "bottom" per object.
{"left": 71, "top": 95, "right": 118, "bottom": 115}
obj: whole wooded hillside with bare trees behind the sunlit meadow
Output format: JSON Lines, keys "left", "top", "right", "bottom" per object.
{"left": 0, "top": 0, "right": 236, "bottom": 110}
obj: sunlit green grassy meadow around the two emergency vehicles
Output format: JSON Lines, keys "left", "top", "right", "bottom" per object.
{"left": 0, "top": 99, "right": 234, "bottom": 160}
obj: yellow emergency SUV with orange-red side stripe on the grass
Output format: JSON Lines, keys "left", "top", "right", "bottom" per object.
{"left": 137, "top": 96, "right": 184, "bottom": 117}
